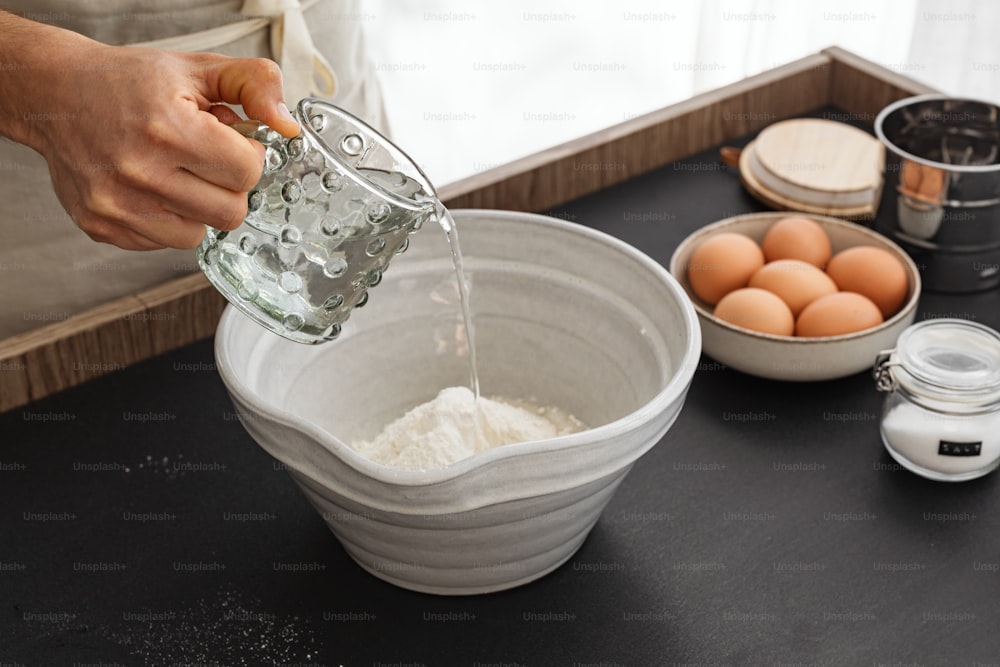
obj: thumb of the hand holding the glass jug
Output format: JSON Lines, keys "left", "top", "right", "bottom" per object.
{"left": 203, "top": 58, "right": 301, "bottom": 138}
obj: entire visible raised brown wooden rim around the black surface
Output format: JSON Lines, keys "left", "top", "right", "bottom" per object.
{"left": 0, "top": 47, "right": 934, "bottom": 412}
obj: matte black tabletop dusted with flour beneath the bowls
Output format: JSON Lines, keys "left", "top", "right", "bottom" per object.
{"left": 0, "top": 111, "right": 1000, "bottom": 667}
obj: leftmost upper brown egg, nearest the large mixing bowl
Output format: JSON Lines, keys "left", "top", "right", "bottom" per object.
{"left": 687, "top": 232, "right": 764, "bottom": 304}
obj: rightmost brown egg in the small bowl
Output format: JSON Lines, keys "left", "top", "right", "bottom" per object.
{"left": 826, "top": 246, "right": 909, "bottom": 318}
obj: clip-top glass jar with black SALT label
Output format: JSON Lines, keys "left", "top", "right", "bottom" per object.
{"left": 874, "top": 319, "right": 1000, "bottom": 482}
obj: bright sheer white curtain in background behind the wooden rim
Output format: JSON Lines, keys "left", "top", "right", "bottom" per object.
{"left": 362, "top": 0, "right": 1000, "bottom": 185}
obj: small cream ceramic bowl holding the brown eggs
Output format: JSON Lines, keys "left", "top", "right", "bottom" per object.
{"left": 670, "top": 212, "right": 920, "bottom": 381}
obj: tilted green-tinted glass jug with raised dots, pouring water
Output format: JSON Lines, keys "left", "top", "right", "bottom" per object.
{"left": 198, "top": 98, "right": 437, "bottom": 344}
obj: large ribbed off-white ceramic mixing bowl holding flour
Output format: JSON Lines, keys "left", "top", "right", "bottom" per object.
{"left": 216, "top": 210, "right": 701, "bottom": 594}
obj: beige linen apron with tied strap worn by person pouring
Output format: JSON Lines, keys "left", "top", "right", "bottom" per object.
{"left": 0, "top": 0, "right": 386, "bottom": 339}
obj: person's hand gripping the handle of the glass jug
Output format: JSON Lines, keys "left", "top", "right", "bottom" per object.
{"left": 3, "top": 18, "right": 299, "bottom": 250}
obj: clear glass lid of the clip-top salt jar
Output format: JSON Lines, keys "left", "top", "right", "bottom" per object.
{"left": 894, "top": 319, "right": 1000, "bottom": 401}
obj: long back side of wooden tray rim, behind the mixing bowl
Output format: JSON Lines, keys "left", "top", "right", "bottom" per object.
{"left": 440, "top": 54, "right": 832, "bottom": 211}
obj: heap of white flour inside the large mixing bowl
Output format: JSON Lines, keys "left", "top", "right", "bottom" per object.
{"left": 352, "top": 387, "right": 587, "bottom": 470}
